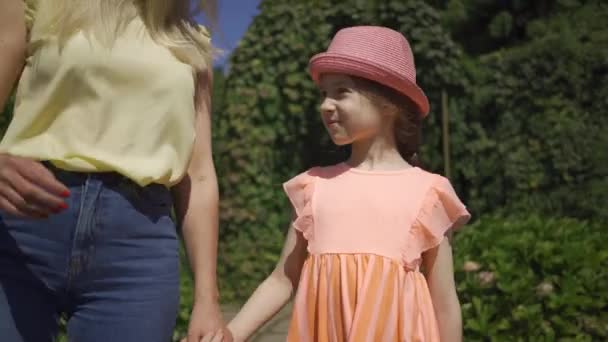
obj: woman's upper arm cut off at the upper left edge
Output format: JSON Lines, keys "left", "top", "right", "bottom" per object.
{"left": 0, "top": 0, "right": 27, "bottom": 111}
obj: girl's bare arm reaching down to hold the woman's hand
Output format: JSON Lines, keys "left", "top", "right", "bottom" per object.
{"left": 228, "top": 220, "right": 308, "bottom": 341}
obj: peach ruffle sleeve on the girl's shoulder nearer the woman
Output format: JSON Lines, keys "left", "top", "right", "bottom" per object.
{"left": 283, "top": 169, "right": 316, "bottom": 240}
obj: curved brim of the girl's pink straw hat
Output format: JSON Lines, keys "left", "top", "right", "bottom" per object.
{"left": 309, "top": 52, "right": 430, "bottom": 117}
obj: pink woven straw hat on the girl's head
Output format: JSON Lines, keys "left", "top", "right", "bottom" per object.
{"left": 309, "top": 26, "right": 429, "bottom": 117}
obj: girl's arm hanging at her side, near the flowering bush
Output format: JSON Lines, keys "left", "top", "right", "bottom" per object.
{"left": 422, "top": 237, "right": 462, "bottom": 342}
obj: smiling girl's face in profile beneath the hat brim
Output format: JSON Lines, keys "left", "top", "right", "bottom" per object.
{"left": 319, "top": 74, "right": 387, "bottom": 145}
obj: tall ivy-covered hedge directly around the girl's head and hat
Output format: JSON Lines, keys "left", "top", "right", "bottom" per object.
{"left": 216, "top": 1, "right": 466, "bottom": 299}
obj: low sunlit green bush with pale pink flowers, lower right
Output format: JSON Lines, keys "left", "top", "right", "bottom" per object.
{"left": 454, "top": 216, "right": 608, "bottom": 341}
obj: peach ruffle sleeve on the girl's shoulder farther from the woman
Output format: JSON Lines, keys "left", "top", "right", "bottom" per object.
{"left": 403, "top": 176, "right": 471, "bottom": 269}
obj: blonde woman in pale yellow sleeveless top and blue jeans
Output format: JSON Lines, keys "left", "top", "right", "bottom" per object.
{"left": 0, "top": 0, "right": 229, "bottom": 342}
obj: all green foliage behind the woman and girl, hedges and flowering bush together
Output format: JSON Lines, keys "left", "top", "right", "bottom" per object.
{"left": 0, "top": 0, "right": 608, "bottom": 341}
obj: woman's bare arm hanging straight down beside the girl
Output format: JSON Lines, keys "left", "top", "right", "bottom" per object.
{"left": 173, "top": 71, "right": 224, "bottom": 342}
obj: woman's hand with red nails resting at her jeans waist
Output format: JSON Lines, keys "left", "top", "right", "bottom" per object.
{"left": 0, "top": 154, "right": 70, "bottom": 218}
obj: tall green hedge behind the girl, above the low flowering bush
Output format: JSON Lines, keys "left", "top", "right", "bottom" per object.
{"left": 215, "top": 0, "right": 608, "bottom": 300}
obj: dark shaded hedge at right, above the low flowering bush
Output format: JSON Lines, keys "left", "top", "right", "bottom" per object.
{"left": 454, "top": 4, "right": 608, "bottom": 222}
